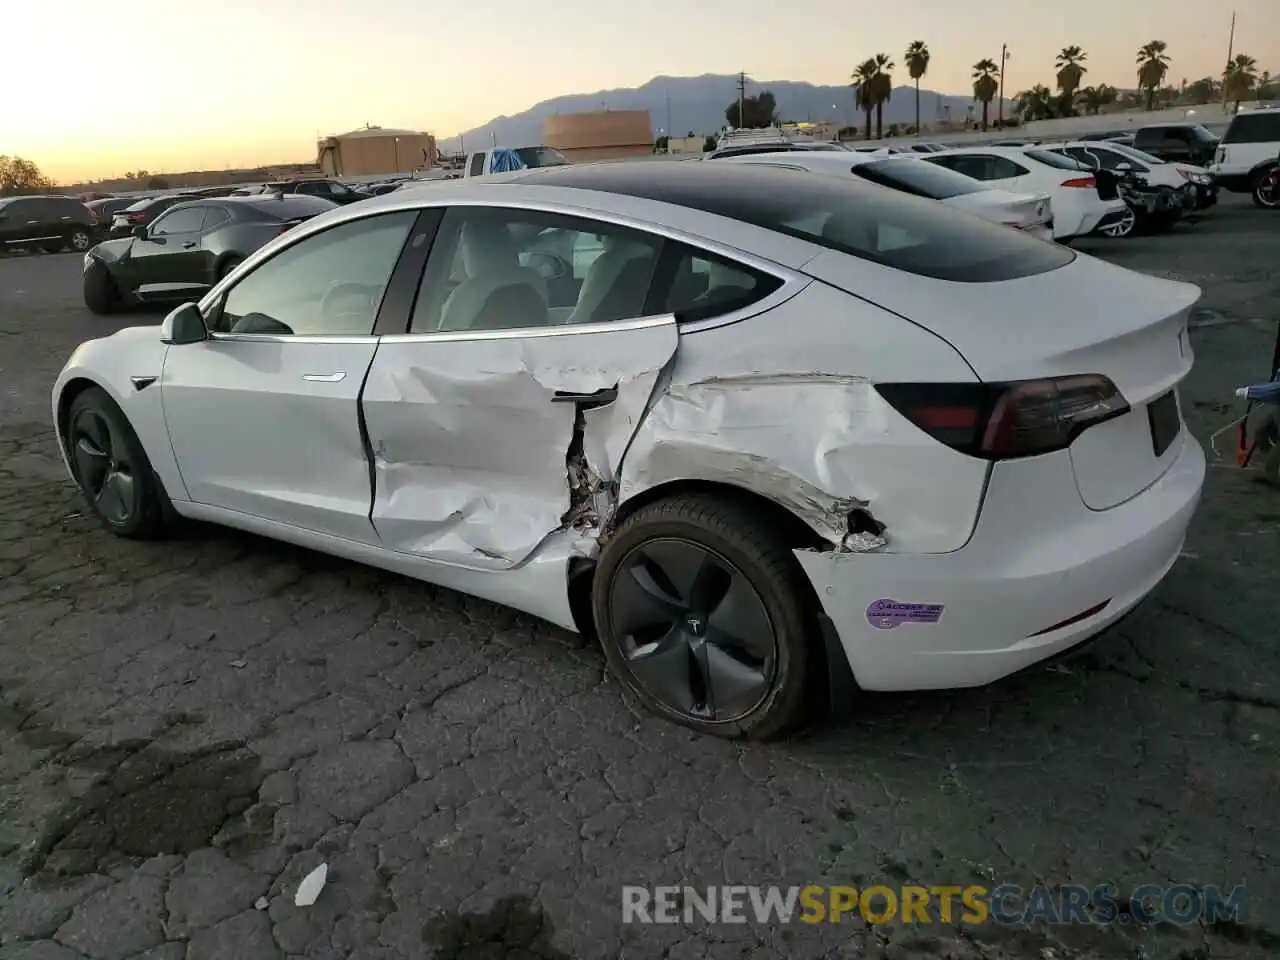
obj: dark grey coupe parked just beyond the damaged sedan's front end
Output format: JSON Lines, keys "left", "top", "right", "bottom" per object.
{"left": 84, "top": 193, "right": 335, "bottom": 314}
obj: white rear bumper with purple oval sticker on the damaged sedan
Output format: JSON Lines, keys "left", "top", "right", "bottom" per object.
{"left": 796, "top": 429, "right": 1204, "bottom": 690}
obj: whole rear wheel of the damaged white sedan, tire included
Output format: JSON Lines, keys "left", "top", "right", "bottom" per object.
{"left": 591, "top": 494, "right": 820, "bottom": 740}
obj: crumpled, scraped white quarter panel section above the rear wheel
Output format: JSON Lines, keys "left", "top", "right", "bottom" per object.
{"left": 620, "top": 372, "right": 986, "bottom": 553}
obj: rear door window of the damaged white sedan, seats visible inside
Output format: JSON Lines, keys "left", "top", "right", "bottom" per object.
{"left": 410, "top": 206, "right": 662, "bottom": 333}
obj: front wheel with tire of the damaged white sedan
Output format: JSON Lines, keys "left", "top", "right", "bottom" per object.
{"left": 64, "top": 387, "right": 173, "bottom": 540}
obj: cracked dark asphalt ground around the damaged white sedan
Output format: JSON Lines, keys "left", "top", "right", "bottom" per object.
{"left": 0, "top": 197, "right": 1280, "bottom": 960}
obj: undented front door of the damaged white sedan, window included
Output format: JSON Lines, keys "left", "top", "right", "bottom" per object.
{"left": 160, "top": 211, "right": 416, "bottom": 543}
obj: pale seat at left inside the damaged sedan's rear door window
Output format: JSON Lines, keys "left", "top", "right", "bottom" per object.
{"left": 439, "top": 219, "right": 548, "bottom": 332}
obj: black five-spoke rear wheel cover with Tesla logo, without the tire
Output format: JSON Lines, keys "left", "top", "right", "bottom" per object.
{"left": 609, "top": 539, "right": 777, "bottom": 723}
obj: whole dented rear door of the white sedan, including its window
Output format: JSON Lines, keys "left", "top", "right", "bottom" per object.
{"left": 362, "top": 206, "right": 678, "bottom": 570}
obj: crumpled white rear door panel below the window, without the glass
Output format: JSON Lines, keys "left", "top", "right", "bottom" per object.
{"left": 362, "top": 316, "right": 678, "bottom": 570}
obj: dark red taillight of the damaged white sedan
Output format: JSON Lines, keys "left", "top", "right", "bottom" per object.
{"left": 876, "top": 374, "right": 1129, "bottom": 460}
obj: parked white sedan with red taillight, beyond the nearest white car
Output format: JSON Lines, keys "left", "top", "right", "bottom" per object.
{"left": 920, "top": 146, "right": 1133, "bottom": 241}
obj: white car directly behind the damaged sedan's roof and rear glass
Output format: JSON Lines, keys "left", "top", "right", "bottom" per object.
{"left": 716, "top": 154, "right": 1053, "bottom": 239}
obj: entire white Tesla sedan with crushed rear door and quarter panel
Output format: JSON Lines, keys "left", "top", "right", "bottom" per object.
{"left": 52, "top": 163, "right": 1204, "bottom": 737}
